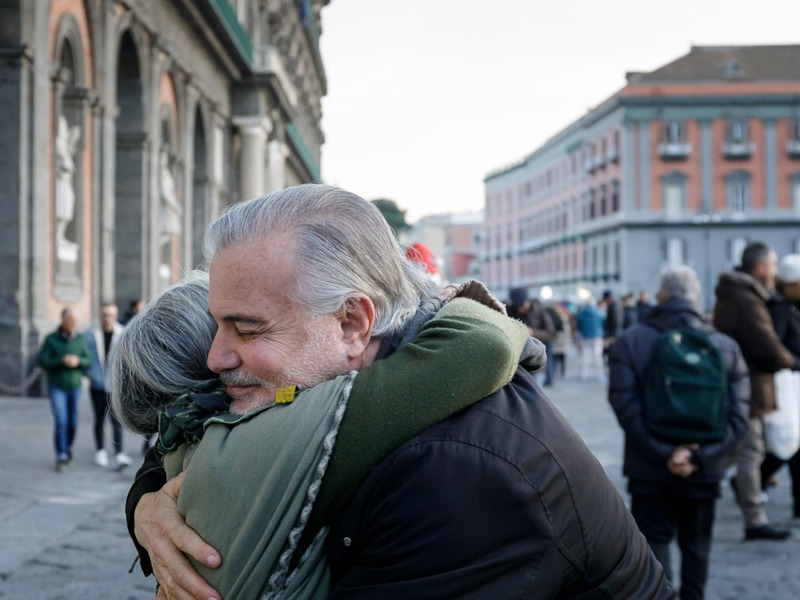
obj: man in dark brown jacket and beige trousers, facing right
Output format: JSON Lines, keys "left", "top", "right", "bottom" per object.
{"left": 714, "top": 242, "right": 800, "bottom": 540}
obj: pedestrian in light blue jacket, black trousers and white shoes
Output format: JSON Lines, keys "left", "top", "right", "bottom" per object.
{"left": 86, "top": 302, "right": 131, "bottom": 469}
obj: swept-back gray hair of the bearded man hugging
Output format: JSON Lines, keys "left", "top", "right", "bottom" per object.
{"left": 204, "top": 184, "right": 436, "bottom": 338}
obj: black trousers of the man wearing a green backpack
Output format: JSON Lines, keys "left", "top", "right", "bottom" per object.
{"left": 631, "top": 494, "right": 717, "bottom": 600}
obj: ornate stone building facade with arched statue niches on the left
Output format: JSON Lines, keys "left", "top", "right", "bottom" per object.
{"left": 0, "top": 0, "right": 329, "bottom": 387}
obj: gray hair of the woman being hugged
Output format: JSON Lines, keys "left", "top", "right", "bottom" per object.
{"left": 107, "top": 271, "right": 217, "bottom": 434}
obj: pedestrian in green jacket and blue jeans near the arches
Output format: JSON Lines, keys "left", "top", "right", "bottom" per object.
{"left": 39, "top": 308, "right": 91, "bottom": 473}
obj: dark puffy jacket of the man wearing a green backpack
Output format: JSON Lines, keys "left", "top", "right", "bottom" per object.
{"left": 608, "top": 300, "right": 750, "bottom": 491}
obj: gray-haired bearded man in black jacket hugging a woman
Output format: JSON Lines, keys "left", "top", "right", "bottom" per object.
{"left": 126, "top": 185, "right": 674, "bottom": 599}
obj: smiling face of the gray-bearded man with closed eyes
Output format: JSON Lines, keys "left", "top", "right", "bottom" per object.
{"left": 208, "top": 235, "right": 348, "bottom": 414}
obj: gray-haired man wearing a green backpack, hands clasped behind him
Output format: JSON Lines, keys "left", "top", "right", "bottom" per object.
{"left": 609, "top": 267, "right": 750, "bottom": 600}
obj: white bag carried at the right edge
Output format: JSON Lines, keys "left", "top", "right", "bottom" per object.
{"left": 764, "top": 369, "right": 800, "bottom": 460}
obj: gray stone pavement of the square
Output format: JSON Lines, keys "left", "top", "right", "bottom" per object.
{"left": 0, "top": 371, "right": 800, "bottom": 600}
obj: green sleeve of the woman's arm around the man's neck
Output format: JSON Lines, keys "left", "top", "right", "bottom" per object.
{"left": 309, "top": 298, "right": 528, "bottom": 531}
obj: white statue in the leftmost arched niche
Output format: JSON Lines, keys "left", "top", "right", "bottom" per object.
{"left": 55, "top": 115, "right": 81, "bottom": 262}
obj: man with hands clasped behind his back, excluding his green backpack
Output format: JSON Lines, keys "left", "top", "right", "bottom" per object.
{"left": 609, "top": 267, "right": 750, "bottom": 600}
